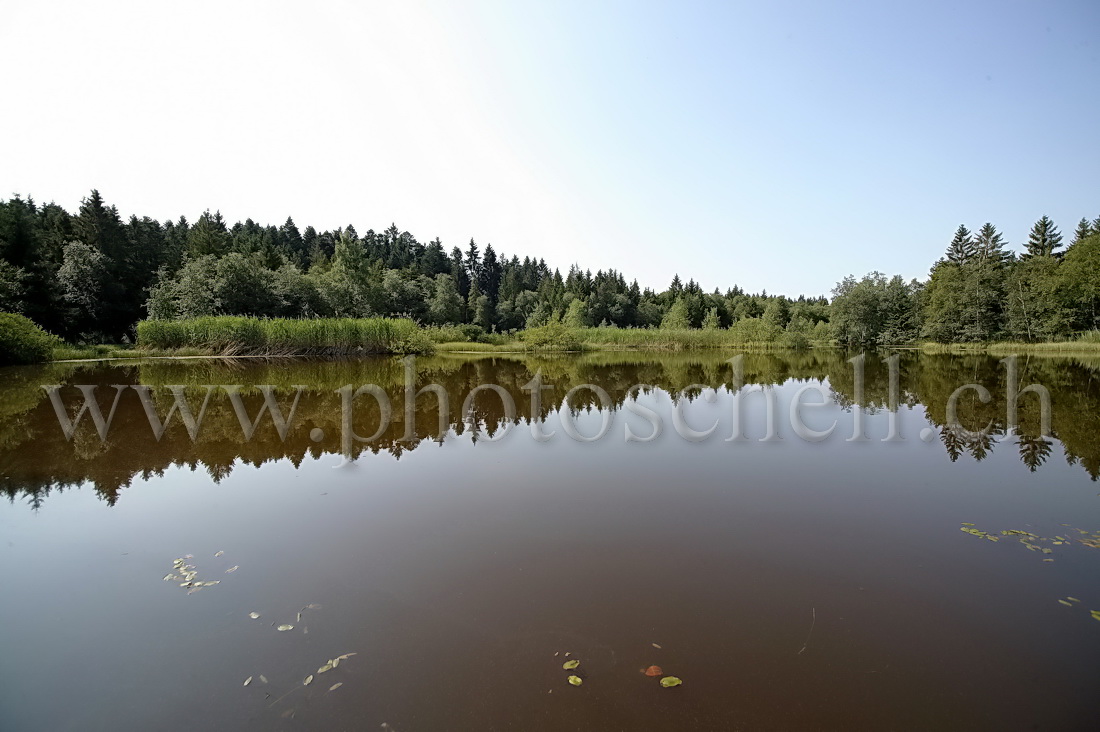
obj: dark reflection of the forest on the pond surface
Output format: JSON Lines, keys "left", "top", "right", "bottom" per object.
{"left": 0, "top": 351, "right": 1100, "bottom": 507}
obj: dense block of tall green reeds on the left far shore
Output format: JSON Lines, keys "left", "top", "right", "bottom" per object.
{"left": 138, "top": 316, "right": 433, "bottom": 356}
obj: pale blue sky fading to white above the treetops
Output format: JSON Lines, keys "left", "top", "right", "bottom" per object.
{"left": 0, "top": 0, "right": 1100, "bottom": 296}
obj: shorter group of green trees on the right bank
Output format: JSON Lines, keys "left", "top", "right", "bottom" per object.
{"left": 831, "top": 216, "right": 1100, "bottom": 345}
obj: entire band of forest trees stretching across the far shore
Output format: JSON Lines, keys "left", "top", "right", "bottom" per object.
{"left": 0, "top": 190, "right": 1100, "bottom": 346}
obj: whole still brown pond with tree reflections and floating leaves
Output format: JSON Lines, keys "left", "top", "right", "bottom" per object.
{"left": 0, "top": 352, "right": 1100, "bottom": 732}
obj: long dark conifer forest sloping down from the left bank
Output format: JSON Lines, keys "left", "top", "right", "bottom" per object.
{"left": 0, "top": 190, "right": 828, "bottom": 340}
